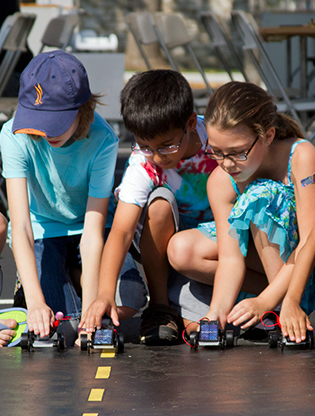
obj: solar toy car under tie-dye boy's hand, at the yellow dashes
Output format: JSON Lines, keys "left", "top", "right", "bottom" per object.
{"left": 81, "top": 319, "right": 124, "bottom": 353}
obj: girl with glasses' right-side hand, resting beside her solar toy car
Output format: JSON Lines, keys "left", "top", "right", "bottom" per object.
{"left": 227, "top": 297, "right": 266, "bottom": 329}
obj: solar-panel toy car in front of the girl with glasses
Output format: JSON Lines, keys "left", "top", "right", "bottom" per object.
{"left": 190, "top": 319, "right": 234, "bottom": 351}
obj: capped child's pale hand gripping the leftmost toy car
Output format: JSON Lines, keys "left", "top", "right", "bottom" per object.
{"left": 27, "top": 303, "right": 55, "bottom": 338}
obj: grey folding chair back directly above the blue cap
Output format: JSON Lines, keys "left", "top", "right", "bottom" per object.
{"left": 39, "top": 13, "right": 79, "bottom": 53}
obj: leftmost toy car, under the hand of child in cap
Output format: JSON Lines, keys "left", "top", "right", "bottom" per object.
{"left": 21, "top": 327, "right": 65, "bottom": 351}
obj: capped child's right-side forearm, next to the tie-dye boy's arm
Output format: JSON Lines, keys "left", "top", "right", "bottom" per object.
{"left": 80, "top": 197, "right": 109, "bottom": 313}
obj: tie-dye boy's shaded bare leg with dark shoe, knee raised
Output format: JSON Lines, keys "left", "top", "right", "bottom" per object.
{"left": 140, "top": 198, "right": 178, "bottom": 345}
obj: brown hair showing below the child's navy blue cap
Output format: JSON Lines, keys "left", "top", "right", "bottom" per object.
{"left": 29, "top": 94, "right": 102, "bottom": 140}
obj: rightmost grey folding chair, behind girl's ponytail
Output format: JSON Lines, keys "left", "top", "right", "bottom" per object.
{"left": 231, "top": 10, "right": 315, "bottom": 140}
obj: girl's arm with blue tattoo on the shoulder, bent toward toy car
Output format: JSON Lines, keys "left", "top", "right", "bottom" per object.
{"left": 228, "top": 142, "right": 315, "bottom": 328}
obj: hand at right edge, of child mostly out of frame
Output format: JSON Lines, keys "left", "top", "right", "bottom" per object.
{"left": 280, "top": 300, "right": 313, "bottom": 343}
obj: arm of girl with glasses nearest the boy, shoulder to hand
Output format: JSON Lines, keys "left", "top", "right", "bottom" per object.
{"left": 206, "top": 167, "right": 246, "bottom": 328}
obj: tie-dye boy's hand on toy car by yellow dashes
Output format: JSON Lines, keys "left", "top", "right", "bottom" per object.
{"left": 79, "top": 297, "right": 119, "bottom": 332}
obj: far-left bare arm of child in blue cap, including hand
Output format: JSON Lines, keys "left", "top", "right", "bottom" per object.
{"left": 6, "top": 178, "right": 54, "bottom": 337}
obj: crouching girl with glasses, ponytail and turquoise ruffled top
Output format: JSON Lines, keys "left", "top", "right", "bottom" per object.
{"left": 168, "top": 82, "right": 315, "bottom": 338}
